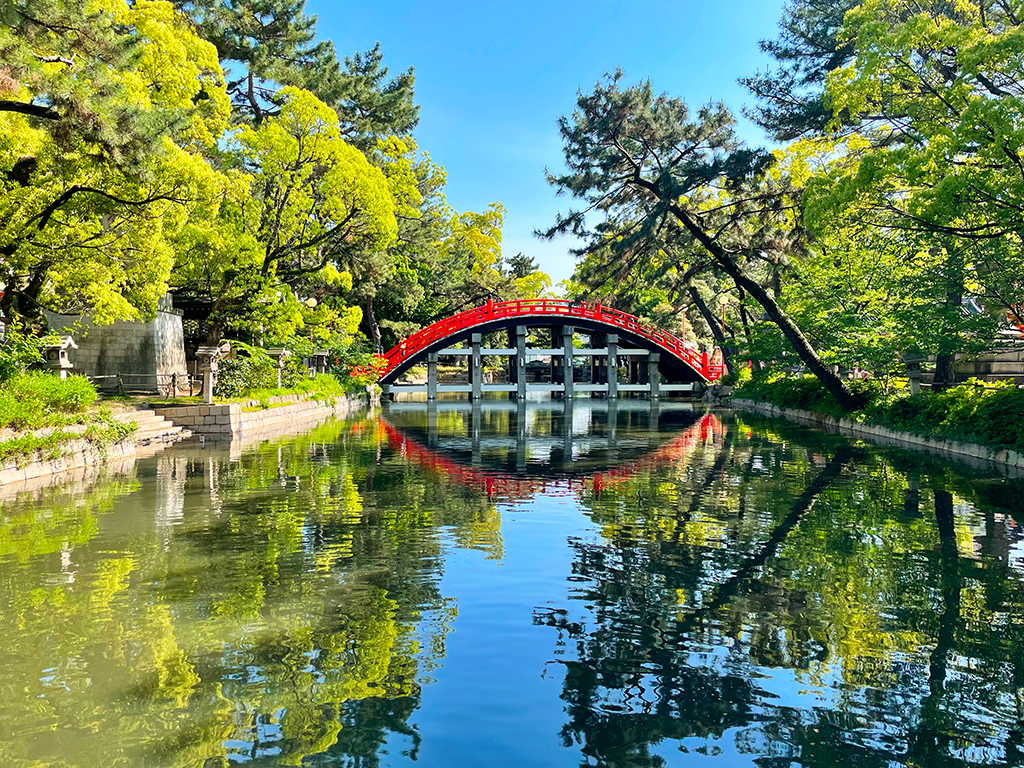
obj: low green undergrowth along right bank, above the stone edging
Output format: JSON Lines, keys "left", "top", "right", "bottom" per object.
{"left": 735, "top": 374, "right": 1024, "bottom": 450}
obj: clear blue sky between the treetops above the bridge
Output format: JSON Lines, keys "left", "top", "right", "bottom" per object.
{"left": 315, "top": 0, "right": 782, "bottom": 283}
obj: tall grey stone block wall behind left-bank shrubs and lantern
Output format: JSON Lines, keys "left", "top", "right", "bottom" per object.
{"left": 46, "top": 294, "right": 185, "bottom": 392}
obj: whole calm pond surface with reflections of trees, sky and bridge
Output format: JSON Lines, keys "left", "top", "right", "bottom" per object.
{"left": 0, "top": 400, "right": 1024, "bottom": 768}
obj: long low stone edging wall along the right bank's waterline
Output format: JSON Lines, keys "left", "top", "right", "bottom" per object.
{"left": 726, "top": 397, "right": 1024, "bottom": 476}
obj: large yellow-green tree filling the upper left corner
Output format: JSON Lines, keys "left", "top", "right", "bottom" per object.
{"left": 0, "top": 0, "right": 228, "bottom": 323}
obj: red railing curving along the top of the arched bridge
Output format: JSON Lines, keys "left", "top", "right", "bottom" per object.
{"left": 364, "top": 299, "right": 724, "bottom": 381}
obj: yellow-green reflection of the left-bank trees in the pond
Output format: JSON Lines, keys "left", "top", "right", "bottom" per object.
{"left": 0, "top": 420, "right": 483, "bottom": 768}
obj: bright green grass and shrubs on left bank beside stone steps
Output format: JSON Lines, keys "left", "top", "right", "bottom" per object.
{"left": 0, "top": 371, "right": 135, "bottom": 465}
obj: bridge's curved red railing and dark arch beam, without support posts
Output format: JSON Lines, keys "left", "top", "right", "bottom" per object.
{"left": 381, "top": 299, "right": 724, "bottom": 387}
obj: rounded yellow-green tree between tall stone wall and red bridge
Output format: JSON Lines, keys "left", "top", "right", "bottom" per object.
{"left": 175, "top": 86, "right": 403, "bottom": 340}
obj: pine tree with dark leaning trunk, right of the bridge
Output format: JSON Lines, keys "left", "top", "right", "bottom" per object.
{"left": 542, "top": 73, "right": 863, "bottom": 411}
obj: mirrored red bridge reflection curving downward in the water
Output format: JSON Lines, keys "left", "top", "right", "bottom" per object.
{"left": 381, "top": 400, "right": 723, "bottom": 499}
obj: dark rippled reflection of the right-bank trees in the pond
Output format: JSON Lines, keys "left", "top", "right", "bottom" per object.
{"left": 535, "top": 419, "right": 1024, "bottom": 767}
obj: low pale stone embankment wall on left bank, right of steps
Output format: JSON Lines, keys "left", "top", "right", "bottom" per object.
{"left": 154, "top": 394, "right": 364, "bottom": 439}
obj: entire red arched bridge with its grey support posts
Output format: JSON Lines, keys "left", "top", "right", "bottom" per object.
{"left": 364, "top": 299, "right": 725, "bottom": 399}
